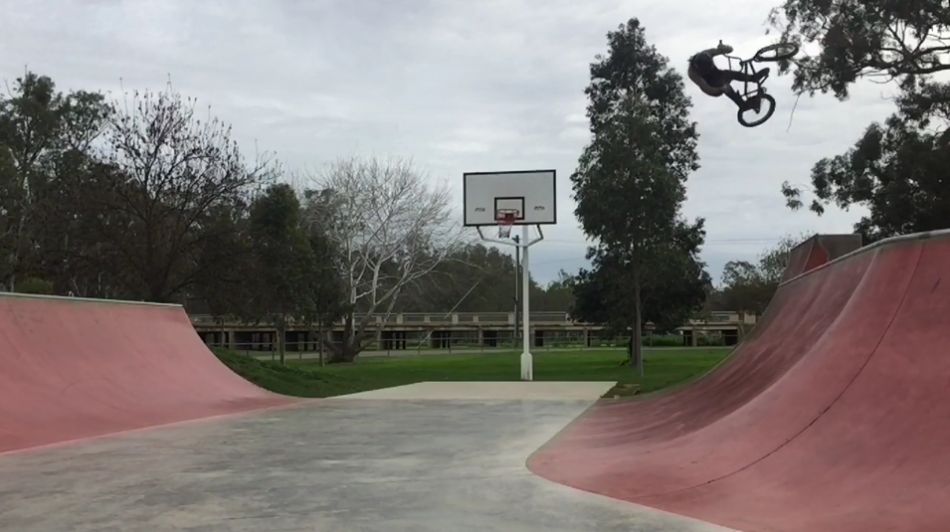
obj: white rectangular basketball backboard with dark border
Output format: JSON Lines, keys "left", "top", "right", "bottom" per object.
{"left": 462, "top": 170, "right": 557, "bottom": 226}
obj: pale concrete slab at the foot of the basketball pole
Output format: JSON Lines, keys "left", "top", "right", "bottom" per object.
{"left": 335, "top": 381, "right": 616, "bottom": 402}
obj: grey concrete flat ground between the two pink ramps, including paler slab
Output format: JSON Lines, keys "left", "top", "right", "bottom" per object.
{"left": 0, "top": 383, "right": 722, "bottom": 532}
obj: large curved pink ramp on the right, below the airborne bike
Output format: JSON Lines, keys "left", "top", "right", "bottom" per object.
{"left": 529, "top": 233, "right": 950, "bottom": 531}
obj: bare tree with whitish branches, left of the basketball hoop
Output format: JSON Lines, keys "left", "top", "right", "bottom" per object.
{"left": 307, "top": 158, "right": 461, "bottom": 362}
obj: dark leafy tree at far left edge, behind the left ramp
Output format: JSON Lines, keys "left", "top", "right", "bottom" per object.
{"left": 0, "top": 72, "right": 110, "bottom": 290}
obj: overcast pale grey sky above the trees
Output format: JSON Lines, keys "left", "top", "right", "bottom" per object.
{"left": 0, "top": 0, "right": 895, "bottom": 282}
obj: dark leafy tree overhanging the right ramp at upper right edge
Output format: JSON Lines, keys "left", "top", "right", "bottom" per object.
{"left": 772, "top": 0, "right": 950, "bottom": 237}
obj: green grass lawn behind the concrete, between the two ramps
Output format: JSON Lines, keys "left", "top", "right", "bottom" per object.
{"left": 216, "top": 347, "right": 730, "bottom": 397}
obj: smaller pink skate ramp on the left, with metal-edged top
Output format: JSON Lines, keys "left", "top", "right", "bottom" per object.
{"left": 0, "top": 294, "right": 293, "bottom": 453}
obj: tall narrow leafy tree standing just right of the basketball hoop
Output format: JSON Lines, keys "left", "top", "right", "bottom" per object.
{"left": 571, "top": 19, "right": 702, "bottom": 374}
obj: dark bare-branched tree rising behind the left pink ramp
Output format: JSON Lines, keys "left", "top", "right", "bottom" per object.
{"left": 89, "top": 82, "right": 276, "bottom": 301}
